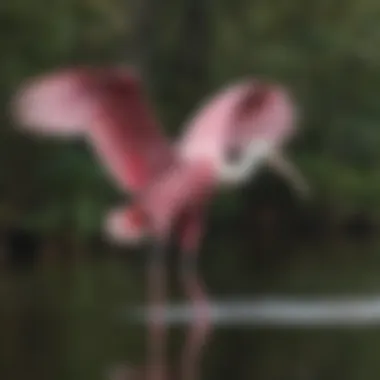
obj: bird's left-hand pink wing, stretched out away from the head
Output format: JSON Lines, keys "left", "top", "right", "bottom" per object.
{"left": 13, "top": 67, "right": 173, "bottom": 192}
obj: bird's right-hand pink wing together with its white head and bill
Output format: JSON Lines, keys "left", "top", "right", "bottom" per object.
{"left": 178, "top": 79, "right": 308, "bottom": 195}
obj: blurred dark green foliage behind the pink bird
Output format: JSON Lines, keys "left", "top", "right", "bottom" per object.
{"left": 0, "top": 0, "right": 380, "bottom": 245}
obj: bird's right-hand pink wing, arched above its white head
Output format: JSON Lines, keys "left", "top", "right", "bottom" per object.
{"left": 178, "top": 79, "right": 294, "bottom": 166}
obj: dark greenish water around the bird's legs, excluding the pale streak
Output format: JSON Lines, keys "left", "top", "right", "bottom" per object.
{"left": 0, "top": 239, "right": 380, "bottom": 380}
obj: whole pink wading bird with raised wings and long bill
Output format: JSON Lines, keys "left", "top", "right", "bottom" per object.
{"left": 13, "top": 67, "right": 307, "bottom": 379}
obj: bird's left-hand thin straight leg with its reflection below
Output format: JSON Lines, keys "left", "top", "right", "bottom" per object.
{"left": 147, "top": 243, "right": 166, "bottom": 380}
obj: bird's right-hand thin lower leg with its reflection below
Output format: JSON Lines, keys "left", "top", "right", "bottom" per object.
{"left": 180, "top": 254, "right": 211, "bottom": 380}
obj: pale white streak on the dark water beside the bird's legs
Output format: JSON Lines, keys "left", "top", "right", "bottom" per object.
{"left": 135, "top": 295, "right": 380, "bottom": 328}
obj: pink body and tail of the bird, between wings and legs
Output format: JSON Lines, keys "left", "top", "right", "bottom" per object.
{"left": 106, "top": 161, "right": 217, "bottom": 250}
